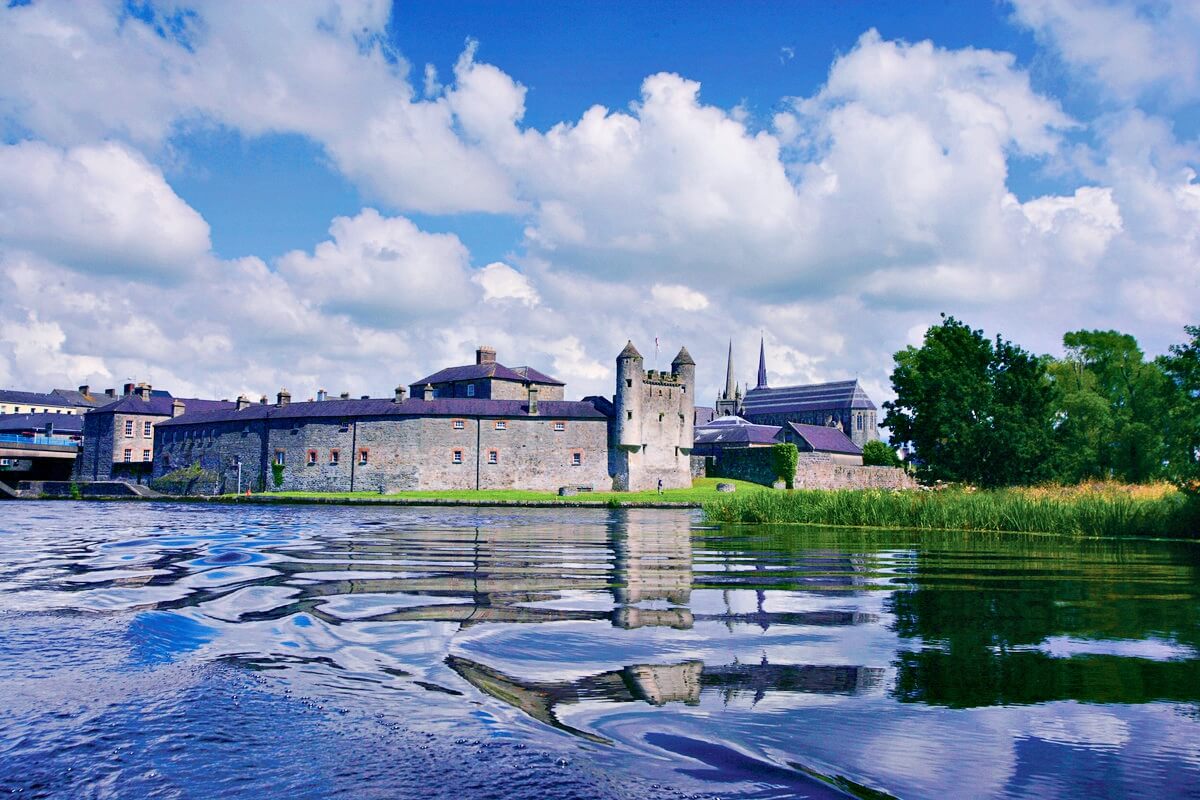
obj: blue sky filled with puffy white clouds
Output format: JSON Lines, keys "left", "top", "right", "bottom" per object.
{"left": 0, "top": 0, "right": 1200, "bottom": 401}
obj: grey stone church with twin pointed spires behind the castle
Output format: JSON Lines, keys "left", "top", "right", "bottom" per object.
{"left": 715, "top": 341, "right": 880, "bottom": 447}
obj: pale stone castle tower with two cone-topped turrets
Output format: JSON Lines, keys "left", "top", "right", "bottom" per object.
{"left": 610, "top": 342, "right": 696, "bottom": 492}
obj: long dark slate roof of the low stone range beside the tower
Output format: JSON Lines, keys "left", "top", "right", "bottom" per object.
{"left": 157, "top": 397, "right": 607, "bottom": 428}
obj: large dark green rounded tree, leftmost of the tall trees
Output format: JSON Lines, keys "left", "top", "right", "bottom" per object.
{"left": 883, "top": 314, "right": 1052, "bottom": 486}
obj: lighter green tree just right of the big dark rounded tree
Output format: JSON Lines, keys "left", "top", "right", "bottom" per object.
{"left": 1050, "top": 331, "right": 1172, "bottom": 482}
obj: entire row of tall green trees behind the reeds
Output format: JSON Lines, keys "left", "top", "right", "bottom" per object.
{"left": 883, "top": 314, "right": 1200, "bottom": 487}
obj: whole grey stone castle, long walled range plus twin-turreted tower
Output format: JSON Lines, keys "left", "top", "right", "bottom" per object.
{"left": 152, "top": 342, "right": 696, "bottom": 493}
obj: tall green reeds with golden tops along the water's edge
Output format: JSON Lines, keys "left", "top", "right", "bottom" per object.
{"left": 703, "top": 485, "right": 1200, "bottom": 537}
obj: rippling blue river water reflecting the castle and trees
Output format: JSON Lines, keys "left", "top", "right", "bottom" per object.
{"left": 0, "top": 503, "right": 1200, "bottom": 800}
